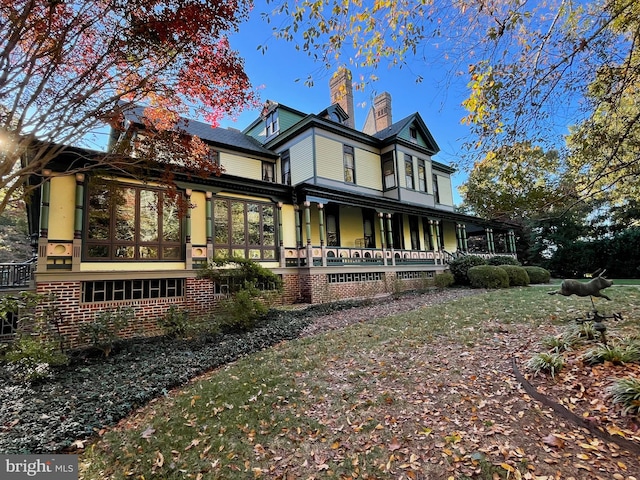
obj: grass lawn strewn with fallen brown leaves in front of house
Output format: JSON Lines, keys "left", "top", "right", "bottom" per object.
{"left": 80, "top": 287, "right": 640, "bottom": 480}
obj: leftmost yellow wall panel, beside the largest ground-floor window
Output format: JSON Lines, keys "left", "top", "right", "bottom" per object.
{"left": 49, "top": 175, "right": 76, "bottom": 240}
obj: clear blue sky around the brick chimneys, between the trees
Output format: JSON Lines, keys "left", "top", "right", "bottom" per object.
{"left": 220, "top": 6, "right": 476, "bottom": 204}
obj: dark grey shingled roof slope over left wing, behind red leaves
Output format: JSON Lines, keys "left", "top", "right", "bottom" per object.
{"left": 124, "top": 106, "right": 278, "bottom": 158}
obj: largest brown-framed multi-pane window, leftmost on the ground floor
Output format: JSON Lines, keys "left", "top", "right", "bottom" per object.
{"left": 84, "top": 179, "right": 183, "bottom": 261}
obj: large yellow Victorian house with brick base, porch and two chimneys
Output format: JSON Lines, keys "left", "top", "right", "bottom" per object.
{"left": 11, "top": 71, "right": 515, "bottom": 344}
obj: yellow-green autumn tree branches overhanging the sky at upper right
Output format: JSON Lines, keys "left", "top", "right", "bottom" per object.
{"left": 265, "top": 0, "right": 640, "bottom": 204}
